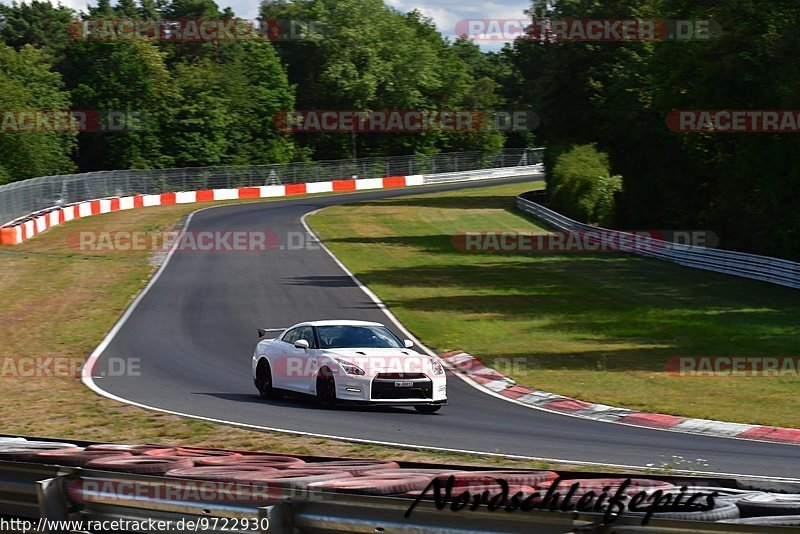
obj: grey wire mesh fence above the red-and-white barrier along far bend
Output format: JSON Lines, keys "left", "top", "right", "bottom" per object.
{"left": 0, "top": 148, "right": 544, "bottom": 225}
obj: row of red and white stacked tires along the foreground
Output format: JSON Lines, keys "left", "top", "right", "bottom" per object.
{"left": 0, "top": 438, "right": 800, "bottom": 527}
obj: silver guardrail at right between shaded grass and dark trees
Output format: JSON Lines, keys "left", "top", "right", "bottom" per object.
{"left": 517, "top": 192, "right": 800, "bottom": 289}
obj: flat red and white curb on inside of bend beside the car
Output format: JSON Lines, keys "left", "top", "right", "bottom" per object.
{"left": 439, "top": 351, "right": 800, "bottom": 445}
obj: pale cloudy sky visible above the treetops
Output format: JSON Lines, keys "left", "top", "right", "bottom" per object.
{"left": 6, "top": 0, "right": 531, "bottom": 51}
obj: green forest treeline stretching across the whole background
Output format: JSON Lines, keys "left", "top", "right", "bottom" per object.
{"left": 0, "top": 0, "right": 800, "bottom": 259}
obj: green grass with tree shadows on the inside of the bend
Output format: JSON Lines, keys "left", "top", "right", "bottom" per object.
{"left": 309, "top": 183, "right": 800, "bottom": 427}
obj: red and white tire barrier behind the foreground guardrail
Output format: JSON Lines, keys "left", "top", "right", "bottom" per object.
{"left": 0, "top": 437, "right": 800, "bottom": 527}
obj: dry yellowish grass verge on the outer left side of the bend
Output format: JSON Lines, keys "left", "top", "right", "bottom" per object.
{"left": 0, "top": 188, "right": 597, "bottom": 470}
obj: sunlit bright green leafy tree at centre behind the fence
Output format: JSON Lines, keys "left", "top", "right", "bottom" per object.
{"left": 260, "top": 0, "right": 502, "bottom": 159}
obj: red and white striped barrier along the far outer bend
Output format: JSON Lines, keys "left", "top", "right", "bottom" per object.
{"left": 0, "top": 174, "right": 425, "bottom": 245}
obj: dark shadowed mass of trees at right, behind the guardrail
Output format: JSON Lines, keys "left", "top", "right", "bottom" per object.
{"left": 500, "top": 0, "right": 800, "bottom": 258}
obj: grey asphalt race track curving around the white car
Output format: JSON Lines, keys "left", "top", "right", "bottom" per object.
{"left": 89, "top": 178, "right": 800, "bottom": 478}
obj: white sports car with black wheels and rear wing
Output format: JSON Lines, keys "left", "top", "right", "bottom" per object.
{"left": 253, "top": 321, "right": 447, "bottom": 413}
